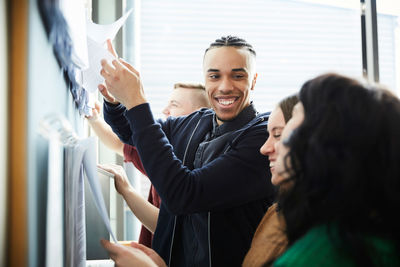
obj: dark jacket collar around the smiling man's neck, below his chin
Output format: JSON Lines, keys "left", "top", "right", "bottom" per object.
{"left": 211, "top": 102, "right": 257, "bottom": 138}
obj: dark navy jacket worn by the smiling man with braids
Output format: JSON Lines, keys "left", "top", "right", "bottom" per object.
{"left": 104, "top": 104, "right": 274, "bottom": 267}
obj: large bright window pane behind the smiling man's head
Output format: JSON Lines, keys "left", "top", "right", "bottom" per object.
{"left": 137, "top": 0, "right": 362, "bottom": 117}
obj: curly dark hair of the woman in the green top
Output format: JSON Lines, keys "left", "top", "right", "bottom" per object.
{"left": 279, "top": 73, "right": 400, "bottom": 266}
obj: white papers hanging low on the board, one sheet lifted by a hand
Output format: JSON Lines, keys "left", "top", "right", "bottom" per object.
{"left": 65, "top": 137, "right": 117, "bottom": 267}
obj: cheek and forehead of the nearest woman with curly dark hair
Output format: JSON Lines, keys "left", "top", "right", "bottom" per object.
{"left": 273, "top": 102, "right": 304, "bottom": 184}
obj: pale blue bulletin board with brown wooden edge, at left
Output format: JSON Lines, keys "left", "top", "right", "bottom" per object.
{"left": 7, "top": 0, "right": 84, "bottom": 267}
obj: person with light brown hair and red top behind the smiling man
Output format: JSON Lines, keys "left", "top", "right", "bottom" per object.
{"left": 87, "top": 82, "right": 210, "bottom": 247}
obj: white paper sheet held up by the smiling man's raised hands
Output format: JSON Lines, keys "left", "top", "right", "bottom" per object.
{"left": 82, "top": 9, "right": 132, "bottom": 92}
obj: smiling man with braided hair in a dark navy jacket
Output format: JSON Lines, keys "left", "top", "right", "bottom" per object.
{"left": 100, "top": 36, "right": 274, "bottom": 267}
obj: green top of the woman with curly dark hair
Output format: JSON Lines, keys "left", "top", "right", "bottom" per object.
{"left": 273, "top": 225, "right": 400, "bottom": 267}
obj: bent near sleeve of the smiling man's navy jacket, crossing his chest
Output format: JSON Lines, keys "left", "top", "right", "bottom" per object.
{"left": 125, "top": 104, "right": 274, "bottom": 214}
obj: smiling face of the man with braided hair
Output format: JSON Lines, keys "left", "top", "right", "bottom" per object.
{"left": 203, "top": 47, "right": 257, "bottom": 124}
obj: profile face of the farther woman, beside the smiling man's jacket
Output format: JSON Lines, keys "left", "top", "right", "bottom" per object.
{"left": 260, "top": 106, "right": 286, "bottom": 185}
